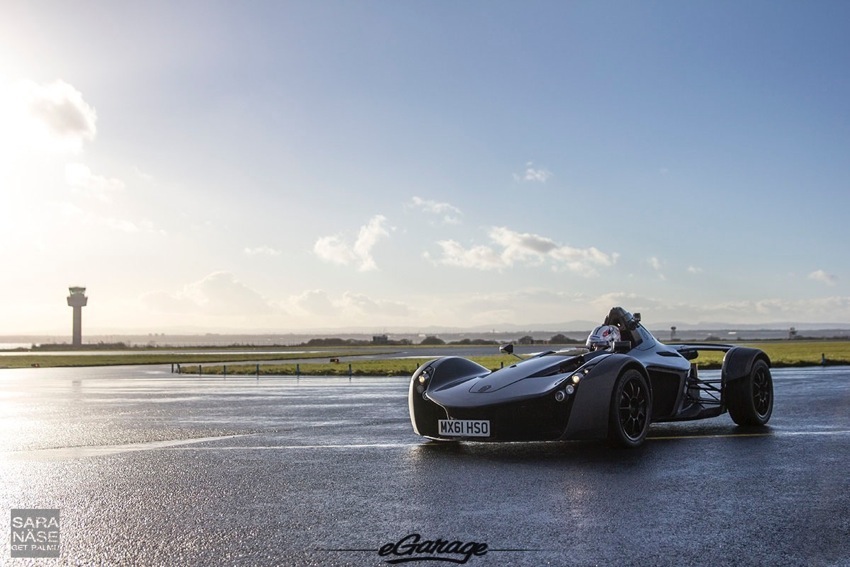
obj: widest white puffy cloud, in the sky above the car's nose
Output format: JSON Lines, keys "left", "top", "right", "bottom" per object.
{"left": 436, "top": 227, "right": 619, "bottom": 276}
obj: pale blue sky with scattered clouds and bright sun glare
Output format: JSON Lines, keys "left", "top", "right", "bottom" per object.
{"left": 0, "top": 0, "right": 850, "bottom": 335}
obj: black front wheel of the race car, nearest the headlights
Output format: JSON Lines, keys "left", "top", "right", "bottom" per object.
{"left": 608, "top": 368, "right": 652, "bottom": 448}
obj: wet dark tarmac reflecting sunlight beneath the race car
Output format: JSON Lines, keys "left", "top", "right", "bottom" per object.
{"left": 0, "top": 367, "right": 850, "bottom": 566}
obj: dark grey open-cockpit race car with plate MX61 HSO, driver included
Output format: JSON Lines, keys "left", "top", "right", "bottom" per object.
{"left": 408, "top": 307, "right": 773, "bottom": 447}
